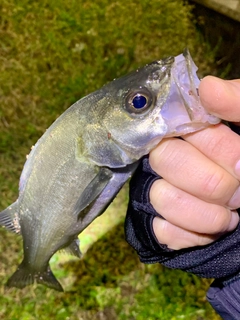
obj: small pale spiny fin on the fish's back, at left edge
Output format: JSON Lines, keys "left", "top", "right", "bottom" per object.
{"left": 0, "top": 201, "right": 21, "bottom": 234}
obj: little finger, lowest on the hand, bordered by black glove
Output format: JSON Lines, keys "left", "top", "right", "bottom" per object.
{"left": 153, "top": 217, "right": 220, "bottom": 250}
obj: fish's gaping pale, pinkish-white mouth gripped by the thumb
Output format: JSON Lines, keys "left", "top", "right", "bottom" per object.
{"left": 161, "top": 49, "right": 220, "bottom": 137}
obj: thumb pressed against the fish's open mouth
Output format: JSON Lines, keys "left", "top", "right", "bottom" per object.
{"left": 199, "top": 76, "right": 240, "bottom": 122}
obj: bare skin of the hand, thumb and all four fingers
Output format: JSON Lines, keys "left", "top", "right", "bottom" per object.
{"left": 149, "top": 76, "right": 240, "bottom": 250}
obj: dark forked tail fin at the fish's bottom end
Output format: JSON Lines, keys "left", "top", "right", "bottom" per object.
{"left": 7, "top": 263, "right": 63, "bottom": 291}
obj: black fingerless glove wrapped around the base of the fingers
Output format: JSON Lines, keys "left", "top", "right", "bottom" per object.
{"left": 125, "top": 157, "right": 240, "bottom": 278}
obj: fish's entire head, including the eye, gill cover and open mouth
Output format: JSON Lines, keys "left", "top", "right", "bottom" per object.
{"left": 84, "top": 50, "right": 220, "bottom": 167}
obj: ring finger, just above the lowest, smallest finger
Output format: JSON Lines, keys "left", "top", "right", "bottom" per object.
{"left": 149, "top": 179, "right": 239, "bottom": 235}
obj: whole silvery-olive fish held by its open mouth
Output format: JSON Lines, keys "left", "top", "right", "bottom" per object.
{"left": 0, "top": 50, "right": 220, "bottom": 291}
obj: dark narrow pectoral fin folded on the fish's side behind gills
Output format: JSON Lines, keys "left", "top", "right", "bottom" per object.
{"left": 74, "top": 168, "right": 113, "bottom": 219}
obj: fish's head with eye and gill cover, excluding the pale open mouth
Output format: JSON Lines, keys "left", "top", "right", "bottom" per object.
{"left": 83, "top": 57, "right": 174, "bottom": 168}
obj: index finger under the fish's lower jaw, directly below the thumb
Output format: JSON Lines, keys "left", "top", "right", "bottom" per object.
{"left": 183, "top": 124, "right": 240, "bottom": 179}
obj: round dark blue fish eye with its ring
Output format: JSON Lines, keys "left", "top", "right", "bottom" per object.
{"left": 126, "top": 88, "right": 152, "bottom": 113}
